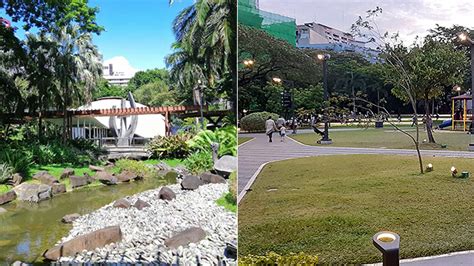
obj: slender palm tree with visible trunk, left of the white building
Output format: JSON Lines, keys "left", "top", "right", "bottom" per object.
{"left": 51, "top": 25, "right": 102, "bottom": 141}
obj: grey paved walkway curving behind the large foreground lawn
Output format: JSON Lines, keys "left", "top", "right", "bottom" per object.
{"left": 238, "top": 133, "right": 474, "bottom": 202}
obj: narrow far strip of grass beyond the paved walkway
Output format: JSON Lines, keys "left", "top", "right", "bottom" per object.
{"left": 289, "top": 127, "right": 474, "bottom": 151}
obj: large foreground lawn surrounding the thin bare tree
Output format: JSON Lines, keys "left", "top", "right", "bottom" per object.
{"left": 239, "top": 155, "right": 474, "bottom": 264}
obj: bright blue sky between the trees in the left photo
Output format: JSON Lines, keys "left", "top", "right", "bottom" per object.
{"left": 0, "top": 0, "right": 194, "bottom": 70}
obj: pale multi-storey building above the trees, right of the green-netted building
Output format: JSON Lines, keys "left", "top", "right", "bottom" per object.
{"left": 296, "top": 22, "right": 379, "bottom": 62}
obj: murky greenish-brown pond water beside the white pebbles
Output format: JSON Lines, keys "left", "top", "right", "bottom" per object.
{"left": 0, "top": 175, "right": 176, "bottom": 264}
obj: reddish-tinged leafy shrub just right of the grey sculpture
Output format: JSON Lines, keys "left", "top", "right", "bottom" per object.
{"left": 147, "top": 134, "right": 190, "bottom": 159}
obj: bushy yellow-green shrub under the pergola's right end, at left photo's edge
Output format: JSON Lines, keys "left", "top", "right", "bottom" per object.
{"left": 188, "top": 126, "right": 237, "bottom": 156}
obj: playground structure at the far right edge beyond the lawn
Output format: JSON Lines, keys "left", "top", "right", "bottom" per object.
{"left": 445, "top": 94, "right": 472, "bottom": 131}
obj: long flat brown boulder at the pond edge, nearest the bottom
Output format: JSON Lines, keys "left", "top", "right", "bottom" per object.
{"left": 43, "top": 226, "right": 122, "bottom": 260}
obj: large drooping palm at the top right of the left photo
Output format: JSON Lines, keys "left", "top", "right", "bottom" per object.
{"left": 167, "top": 0, "right": 237, "bottom": 107}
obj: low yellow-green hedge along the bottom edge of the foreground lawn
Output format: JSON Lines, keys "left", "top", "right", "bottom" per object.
{"left": 239, "top": 252, "right": 318, "bottom": 266}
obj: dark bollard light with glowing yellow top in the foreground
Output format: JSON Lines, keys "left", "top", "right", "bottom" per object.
{"left": 372, "top": 231, "right": 400, "bottom": 266}
